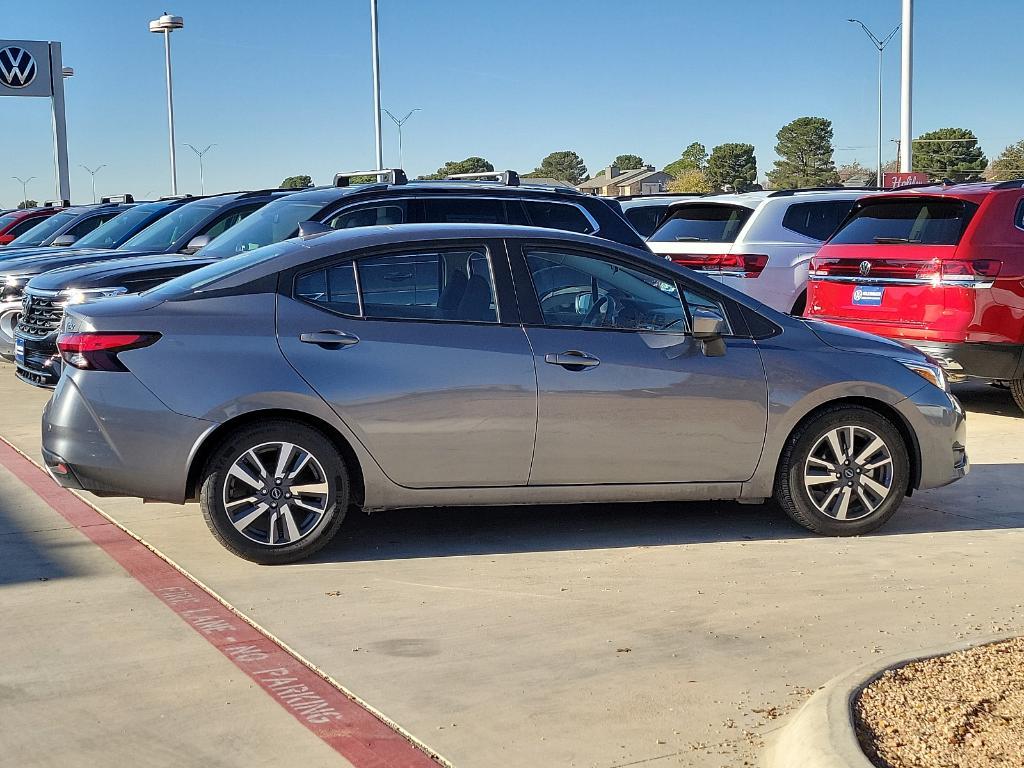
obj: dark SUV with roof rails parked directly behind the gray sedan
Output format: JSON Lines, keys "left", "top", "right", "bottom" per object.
{"left": 15, "top": 170, "right": 643, "bottom": 387}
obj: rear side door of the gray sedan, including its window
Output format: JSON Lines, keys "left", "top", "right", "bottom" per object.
{"left": 278, "top": 241, "right": 537, "bottom": 487}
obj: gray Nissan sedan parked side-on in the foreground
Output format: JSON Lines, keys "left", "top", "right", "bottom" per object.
{"left": 42, "top": 224, "right": 969, "bottom": 563}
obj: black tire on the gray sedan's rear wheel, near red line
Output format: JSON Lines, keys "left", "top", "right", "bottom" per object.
{"left": 200, "top": 420, "right": 349, "bottom": 565}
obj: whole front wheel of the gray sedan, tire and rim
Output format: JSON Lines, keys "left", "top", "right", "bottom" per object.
{"left": 775, "top": 406, "right": 910, "bottom": 536}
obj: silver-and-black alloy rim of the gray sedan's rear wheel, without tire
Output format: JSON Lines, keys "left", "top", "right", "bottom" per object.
{"left": 223, "top": 441, "right": 330, "bottom": 547}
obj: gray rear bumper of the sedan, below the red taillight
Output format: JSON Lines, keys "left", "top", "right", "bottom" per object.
{"left": 42, "top": 371, "right": 215, "bottom": 504}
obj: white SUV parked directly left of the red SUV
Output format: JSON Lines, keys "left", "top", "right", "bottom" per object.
{"left": 647, "top": 188, "right": 864, "bottom": 314}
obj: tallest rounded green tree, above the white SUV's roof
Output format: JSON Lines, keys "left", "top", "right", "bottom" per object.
{"left": 768, "top": 118, "right": 839, "bottom": 189}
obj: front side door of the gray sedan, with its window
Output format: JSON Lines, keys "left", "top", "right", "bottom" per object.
{"left": 517, "top": 244, "right": 768, "bottom": 485}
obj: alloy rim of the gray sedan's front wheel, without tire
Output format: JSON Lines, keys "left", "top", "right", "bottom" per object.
{"left": 804, "top": 426, "right": 894, "bottom": 520}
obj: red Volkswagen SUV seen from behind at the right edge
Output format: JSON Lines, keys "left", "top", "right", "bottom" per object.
{"left": 805, "top": 180, "right": 1024, "bottom": 409}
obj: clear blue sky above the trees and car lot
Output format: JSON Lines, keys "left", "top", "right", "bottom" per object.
{"left": 0, "top": 0, "right": 1024, "bottom": 207}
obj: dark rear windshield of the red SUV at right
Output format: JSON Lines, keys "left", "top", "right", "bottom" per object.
{"left": 829, "top": 198, "right": 978, "bottom": 246}
